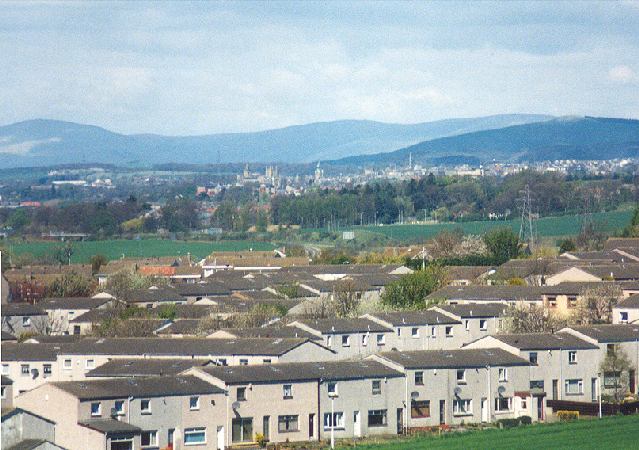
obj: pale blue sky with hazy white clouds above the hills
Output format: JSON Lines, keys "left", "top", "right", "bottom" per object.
{"left": 0, "top": 1, "right": 639, "bottom": 135}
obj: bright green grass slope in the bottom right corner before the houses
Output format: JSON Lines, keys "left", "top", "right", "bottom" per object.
{"left": 356, "top": 415, "right": 639, "bottom": 450}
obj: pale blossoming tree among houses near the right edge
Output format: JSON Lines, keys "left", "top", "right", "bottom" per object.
{"left": 573, "top": 282, "right": 623, "bottom": 324}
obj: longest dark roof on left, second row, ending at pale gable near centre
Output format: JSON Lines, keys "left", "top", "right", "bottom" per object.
{"left": 62, "top": 338, "right": 328, "bottom": 357}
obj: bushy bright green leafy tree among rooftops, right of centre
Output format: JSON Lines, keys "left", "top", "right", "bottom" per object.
{"left": 382, "top": 264, "right": 447, "bottom": 309}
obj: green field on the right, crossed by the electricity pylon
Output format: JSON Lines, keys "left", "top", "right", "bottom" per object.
{"left": 345, "top": 210, "right": 633, "bottom": 242}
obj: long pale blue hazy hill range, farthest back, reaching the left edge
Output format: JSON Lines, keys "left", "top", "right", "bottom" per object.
{"left": 0, "top": 114, "right": 552, "bottom": 168}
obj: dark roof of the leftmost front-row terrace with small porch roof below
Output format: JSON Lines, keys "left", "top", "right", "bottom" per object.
{"left": 51, "top": 375, "right": 224, "bottom": 400}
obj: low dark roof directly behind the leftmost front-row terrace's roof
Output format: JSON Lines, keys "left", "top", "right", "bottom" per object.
{"left": 86, "top": 358, "right": 209, "bottom": 378}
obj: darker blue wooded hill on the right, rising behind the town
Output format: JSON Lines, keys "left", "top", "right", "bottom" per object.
{"left": 332, "top": 117, "right": 639, "bottom": 165}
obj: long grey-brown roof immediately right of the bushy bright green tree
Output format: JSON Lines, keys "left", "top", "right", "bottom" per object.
{"left": 426, "top": 285, "right": 541, "bottom": 302}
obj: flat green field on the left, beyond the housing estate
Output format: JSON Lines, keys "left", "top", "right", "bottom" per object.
{"left": 5, "top": 239, "right": 275, "bottom": 263}
